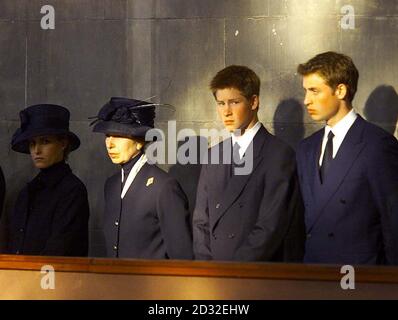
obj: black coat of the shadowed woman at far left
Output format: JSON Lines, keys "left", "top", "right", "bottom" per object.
{"left": 8, "top": 162, "right": 89, "bottom": 256}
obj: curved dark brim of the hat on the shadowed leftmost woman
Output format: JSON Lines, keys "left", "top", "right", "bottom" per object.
{"left": 11, "top": 129, "right": 80, "bottom": 154}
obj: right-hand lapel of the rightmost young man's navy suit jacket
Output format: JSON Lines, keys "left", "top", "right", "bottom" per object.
{"left": 308, "top": 115, "right": 365, "bottom": 230}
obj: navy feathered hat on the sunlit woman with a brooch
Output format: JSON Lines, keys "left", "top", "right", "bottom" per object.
{"left": 90, "top": 97, "right": 157, "bottom": 138}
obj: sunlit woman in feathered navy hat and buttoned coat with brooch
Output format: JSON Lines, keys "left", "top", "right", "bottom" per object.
{"left": 93, "top": 98, "right": 193, "bottom": 259}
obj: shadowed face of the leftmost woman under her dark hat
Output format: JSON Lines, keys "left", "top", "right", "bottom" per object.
{"left": 29, "top": 135, "right": 68, "bottom": 169}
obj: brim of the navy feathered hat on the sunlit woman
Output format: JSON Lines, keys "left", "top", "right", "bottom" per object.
{"left": 93, "top": 121, "right": 154, "bottom": 138}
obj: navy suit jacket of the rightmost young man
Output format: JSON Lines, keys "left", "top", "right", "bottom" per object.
{"left": 297, "top": 116, "right": 398, "bottom": 264}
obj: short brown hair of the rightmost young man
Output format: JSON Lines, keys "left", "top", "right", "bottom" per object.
{"left": 297, "top": 51, "right": 359, "bottom": 102}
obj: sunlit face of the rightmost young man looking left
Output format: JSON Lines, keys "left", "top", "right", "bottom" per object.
{"left": 303, "top": 73, "right": 342, "bottom": 125}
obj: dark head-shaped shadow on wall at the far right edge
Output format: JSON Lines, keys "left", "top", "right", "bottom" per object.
{"left": 364, "top": 85, "right": 398, "bottom": 134}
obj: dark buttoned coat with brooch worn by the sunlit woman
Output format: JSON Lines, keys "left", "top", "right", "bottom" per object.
{"left": 104, "top": 163, "right": 193, "bottom": 259}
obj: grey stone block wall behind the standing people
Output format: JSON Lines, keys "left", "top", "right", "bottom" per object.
{"left": 0, "top": 0, "right": 398, "bottom": 256}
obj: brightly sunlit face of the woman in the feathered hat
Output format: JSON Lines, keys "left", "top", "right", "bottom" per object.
{"left": 105, "top": 135, "right": 142, "bottom": 164}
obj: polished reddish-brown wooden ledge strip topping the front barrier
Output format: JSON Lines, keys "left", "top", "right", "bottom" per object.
{"left": 0, "top": 255, "right": 398, "bottom": 283}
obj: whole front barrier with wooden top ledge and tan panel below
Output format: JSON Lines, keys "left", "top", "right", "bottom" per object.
{"left": 0, "top": 255, "right": 398, "bottom": 299}
